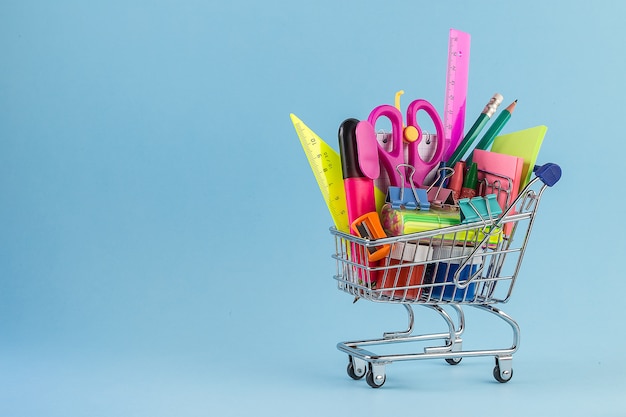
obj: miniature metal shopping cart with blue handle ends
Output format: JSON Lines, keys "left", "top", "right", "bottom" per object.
{"left": 331, "top": 164, "right": 561, "bottom": 388}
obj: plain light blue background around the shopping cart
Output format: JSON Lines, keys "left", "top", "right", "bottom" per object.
{"left": 0, "top": 0, "right": 626, "bottom": 417}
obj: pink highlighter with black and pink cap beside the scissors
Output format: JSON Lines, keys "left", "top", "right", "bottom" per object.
{"left": 338, "top": 119, "right": 380, "bottom": 234}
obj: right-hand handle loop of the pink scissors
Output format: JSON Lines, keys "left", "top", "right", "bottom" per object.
{"left": 406, "top": 99, "right": 445, "bottom": 186}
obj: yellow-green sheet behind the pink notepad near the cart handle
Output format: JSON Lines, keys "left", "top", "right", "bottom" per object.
{"left": 491, "top": 125, "right": 548, "bottom": 189}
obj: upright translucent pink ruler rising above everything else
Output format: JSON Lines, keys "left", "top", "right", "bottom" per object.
{"left": 443, "top": 29, "right": 470, "bottom": 161}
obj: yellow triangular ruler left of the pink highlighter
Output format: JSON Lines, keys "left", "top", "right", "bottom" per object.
{"left": 291, "top": 113, "right": 350, "bottom": 233}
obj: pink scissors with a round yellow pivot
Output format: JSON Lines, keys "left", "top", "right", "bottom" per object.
{"left": 367, "top": 99, "right": 445, "bottom": 187}
